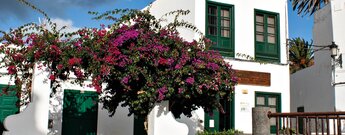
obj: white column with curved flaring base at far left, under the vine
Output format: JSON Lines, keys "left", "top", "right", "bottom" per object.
{"left": 4, "top": 66, "right": 51, "bottom": 135}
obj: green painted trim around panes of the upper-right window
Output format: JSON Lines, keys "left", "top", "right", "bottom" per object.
{"left": 254, "top": 9, "right": 281, "bottom": 63}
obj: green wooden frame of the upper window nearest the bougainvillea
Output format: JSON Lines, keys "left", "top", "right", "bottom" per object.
{"left": 205, "top": 0, "right": 235, "bottom": 57}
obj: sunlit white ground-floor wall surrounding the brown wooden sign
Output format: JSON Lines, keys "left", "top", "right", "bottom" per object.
{"left": 230, "top": 61, "right": 290, "bottom": 133}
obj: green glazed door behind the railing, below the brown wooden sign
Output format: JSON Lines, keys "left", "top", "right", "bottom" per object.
{"left": 255, "top": 92, "right": 281, "bottom": 133}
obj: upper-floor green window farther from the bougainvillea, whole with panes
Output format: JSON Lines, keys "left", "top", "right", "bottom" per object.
{"left": 254, "top": 10, "right": 280, "bottom": 62}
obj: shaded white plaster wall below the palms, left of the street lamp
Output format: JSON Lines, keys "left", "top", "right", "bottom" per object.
{"left": 291, "top": 5, "right": 335, "bottom": 112}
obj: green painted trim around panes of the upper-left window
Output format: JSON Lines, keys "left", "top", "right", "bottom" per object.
{"left": 205, "top": 0, "right": 235, "bottom": 57}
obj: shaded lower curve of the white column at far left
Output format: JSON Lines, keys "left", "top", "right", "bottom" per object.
{"left": 3, "top": 92, "right": 46, "bottom": 135}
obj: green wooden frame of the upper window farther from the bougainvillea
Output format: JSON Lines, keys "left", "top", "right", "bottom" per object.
{"left": 254, "top": 9, "right": 281, "bottom": 62}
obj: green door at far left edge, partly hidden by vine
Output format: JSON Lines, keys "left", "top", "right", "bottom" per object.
{"left": 0, "top": 85, "right": 19, "bottom": 134}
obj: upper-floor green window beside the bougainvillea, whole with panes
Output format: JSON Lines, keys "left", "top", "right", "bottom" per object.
{"left": 206, "top": 1, "right": 234, "bottom": 57}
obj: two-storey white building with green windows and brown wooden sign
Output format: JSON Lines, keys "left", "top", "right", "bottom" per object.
{"left": 151, "top": 0, "right": 290, "bottom": 133}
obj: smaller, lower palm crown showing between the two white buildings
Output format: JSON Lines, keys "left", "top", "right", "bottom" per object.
{"left": 289, "top": 37, "right": 314, "bottom": 74}
